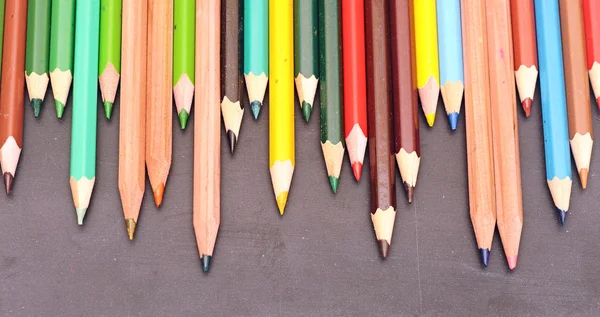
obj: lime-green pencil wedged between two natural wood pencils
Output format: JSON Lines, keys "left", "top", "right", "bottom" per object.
{"left": 172, "top": 0, "right": 196, "bottom": 130}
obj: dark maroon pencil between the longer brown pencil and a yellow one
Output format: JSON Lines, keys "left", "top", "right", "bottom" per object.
{"left": 390, "top": 0, "right": 420, "bottom": 203}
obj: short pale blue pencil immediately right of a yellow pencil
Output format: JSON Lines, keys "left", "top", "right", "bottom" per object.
{"left": 437, "top": 0, "right": 464, "bottom": 130}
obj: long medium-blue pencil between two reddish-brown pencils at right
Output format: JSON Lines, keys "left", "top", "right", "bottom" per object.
{"left": 535, "top": 0, "right": 573, "bottom": 225}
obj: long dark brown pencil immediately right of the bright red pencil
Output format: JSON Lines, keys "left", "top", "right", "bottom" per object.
{"left": 365, "top": 0, "right": 396, "bottom": 258}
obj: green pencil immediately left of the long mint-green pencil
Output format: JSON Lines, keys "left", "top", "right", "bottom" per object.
{"left": 49, "top": 0, "right": 75, "bottom": 119}
